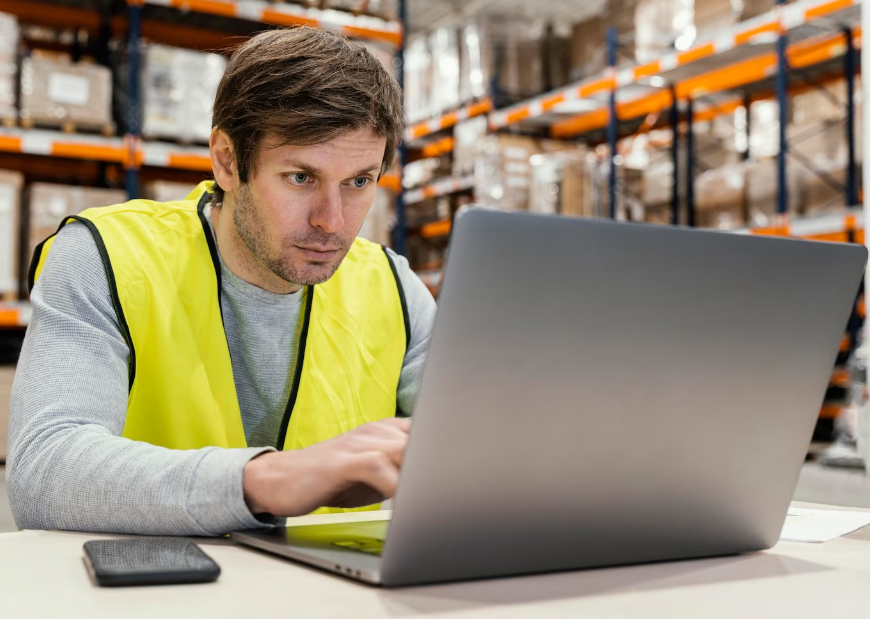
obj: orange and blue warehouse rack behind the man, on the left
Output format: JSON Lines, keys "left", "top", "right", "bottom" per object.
{"left": 0, "top": 0, "right": 405, "bottom": 328}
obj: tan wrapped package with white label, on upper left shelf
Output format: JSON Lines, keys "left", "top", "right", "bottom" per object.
{"left": 19, "top": 54, "right": 114, "bottom": 133}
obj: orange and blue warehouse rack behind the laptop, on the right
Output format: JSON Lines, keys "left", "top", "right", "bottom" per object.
{"left": 406, "top": 0, "right": 863, "bottom": 252}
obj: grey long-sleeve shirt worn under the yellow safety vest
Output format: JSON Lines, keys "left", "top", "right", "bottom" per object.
{"left": 7, "top": 206, "right": 435, "bottom": 535}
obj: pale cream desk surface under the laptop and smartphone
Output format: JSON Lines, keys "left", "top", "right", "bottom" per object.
{"left": 0, "top": 504, "right": 870, "bottom": 619}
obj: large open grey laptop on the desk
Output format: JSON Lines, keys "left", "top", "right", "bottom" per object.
{"left": 232, "top": 209, "right": 867, "bottom": 587}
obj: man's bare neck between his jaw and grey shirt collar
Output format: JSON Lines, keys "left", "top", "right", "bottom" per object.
{"left": 211, "top": 196, "right": 302, "bottom": 294}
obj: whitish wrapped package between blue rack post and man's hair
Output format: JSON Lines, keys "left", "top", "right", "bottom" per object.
{"left": 142, "top": 45, "right": 226, "bottom": 142}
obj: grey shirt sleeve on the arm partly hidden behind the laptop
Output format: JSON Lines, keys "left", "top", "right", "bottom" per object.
{"left": 387, "top": 249, "right": 437, "bottom": 415}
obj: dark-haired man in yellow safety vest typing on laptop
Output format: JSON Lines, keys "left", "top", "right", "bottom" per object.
{"left": 8, "top": 28, "right": 435, "bottom": 535}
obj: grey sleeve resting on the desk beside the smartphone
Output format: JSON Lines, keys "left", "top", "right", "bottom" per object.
{"left": 7, "top": 224, "right": 272, "bottom": 535}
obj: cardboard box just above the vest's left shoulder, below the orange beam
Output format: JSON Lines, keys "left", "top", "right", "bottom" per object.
{"left": 28, "top": 183, "right": 127, "bottom": 256}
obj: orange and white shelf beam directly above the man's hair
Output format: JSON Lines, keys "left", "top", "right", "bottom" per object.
{"left": 141, "top": 0, "right": 402, "bottom": 46}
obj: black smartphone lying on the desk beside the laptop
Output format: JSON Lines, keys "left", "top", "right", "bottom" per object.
{"left": 84, "top": 537, "right": 221, "bottom": 587}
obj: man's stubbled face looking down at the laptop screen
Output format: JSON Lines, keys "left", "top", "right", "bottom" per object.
{"left": 233, "top": 128, "right": 386, "bottom": 286}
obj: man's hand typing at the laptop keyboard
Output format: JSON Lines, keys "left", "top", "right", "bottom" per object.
{"left": 243, "top": 418, "right": 411, "bottom": 517}
